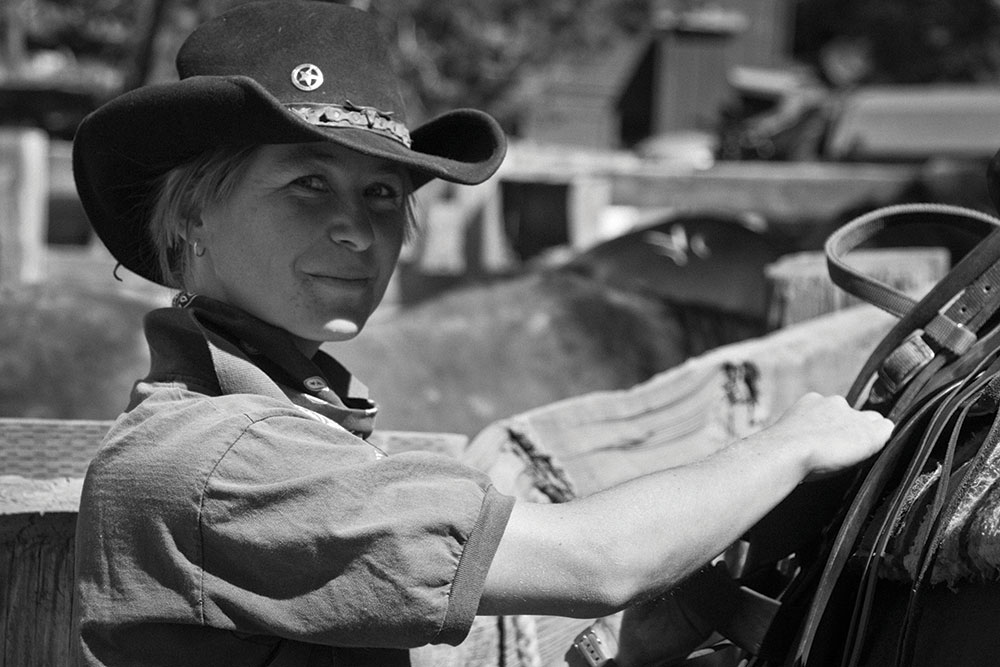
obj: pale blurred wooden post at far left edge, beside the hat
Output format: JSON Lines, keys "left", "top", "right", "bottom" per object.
{"left": 0, "top": 128, "right": 49, "bottom": 286}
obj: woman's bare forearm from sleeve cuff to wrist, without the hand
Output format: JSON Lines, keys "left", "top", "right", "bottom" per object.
{"left": 481, "top": 428, "right": 804, "bottom": 616}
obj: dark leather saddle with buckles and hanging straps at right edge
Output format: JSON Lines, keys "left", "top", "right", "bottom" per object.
{"left": 680, "top": 159, "right": 1000, "bottom": 667}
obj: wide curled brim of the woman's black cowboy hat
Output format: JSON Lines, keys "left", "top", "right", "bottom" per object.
{"left": 73, "top": 76, "right": 506, "bottom": 283}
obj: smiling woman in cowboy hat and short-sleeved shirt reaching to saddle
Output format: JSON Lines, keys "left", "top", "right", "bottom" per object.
{"left": 74, "top": 2, "right": 891, "bottom": 666}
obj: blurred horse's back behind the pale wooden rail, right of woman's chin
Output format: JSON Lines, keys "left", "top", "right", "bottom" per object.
{"left": 329, "top": 211, "right": 779, "bottom": 436}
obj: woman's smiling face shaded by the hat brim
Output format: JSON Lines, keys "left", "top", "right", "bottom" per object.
{"left": 190, "top": 143, "right": 410, "bottom": 348}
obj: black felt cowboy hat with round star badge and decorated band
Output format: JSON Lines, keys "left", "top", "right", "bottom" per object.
{"left": 73, "top": 0, "right": 506, "bottom": 282}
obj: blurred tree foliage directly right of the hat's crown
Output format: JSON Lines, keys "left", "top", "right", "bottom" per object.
{"left": 370, "top": 0, "right": 649, "bottom": 126}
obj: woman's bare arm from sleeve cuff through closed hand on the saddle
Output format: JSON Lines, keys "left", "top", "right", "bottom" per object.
{"left": 479, "top": 394, "right": 892, "bottom": 617}
